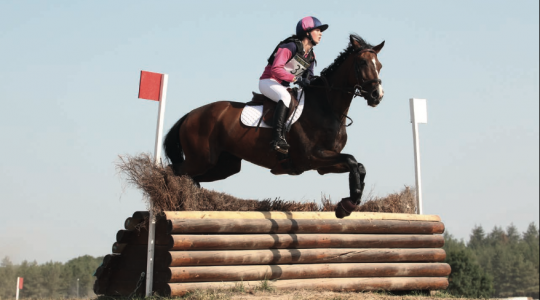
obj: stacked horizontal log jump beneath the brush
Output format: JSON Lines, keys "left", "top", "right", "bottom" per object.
{"left": 94, "top": 211, "right": 451, "bottom": 297}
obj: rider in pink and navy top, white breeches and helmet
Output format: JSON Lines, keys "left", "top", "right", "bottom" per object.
{"left": 259, "top": 17, "right": 328, "bottom": 153}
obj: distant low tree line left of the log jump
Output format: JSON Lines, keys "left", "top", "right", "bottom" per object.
{"left": 0, "top": 255, "right": 103, "bottom": 300}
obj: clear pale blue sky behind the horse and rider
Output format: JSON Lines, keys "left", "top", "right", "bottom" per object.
{"left": 0, "top": 0, "right": 539, "bottom": 263}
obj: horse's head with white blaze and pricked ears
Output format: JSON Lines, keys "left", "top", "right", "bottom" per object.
{"left": 349, "top": 35, "right": 384, "bottom": 107}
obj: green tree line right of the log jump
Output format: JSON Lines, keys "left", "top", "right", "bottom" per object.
{"left": 444, "top": 223, "right": 540, "bottom": 299}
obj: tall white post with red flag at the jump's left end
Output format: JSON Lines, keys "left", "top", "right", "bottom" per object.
{"left": 139, "top": 71, "right": 169, "bottom": 297}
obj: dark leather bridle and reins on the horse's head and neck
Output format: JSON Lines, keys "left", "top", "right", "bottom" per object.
{"left": 309, "top": 49, "right": 382, "bottom": 127}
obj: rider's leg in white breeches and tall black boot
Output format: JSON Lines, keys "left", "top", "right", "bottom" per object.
{"left": 259, "top": 79, "right": 291, "bottom": 153}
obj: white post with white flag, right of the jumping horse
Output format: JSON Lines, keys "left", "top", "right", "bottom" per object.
{"left": 409, "top": 98, "right": 427, "bottom": 215}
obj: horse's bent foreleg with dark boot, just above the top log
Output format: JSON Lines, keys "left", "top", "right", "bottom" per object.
{"left": 314, "top": 151, "right": 366, "bottom": 219}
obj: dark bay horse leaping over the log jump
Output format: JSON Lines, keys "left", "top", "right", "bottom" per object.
{"left": 164, "top": 35, "right": 384, "bottom": 218}
